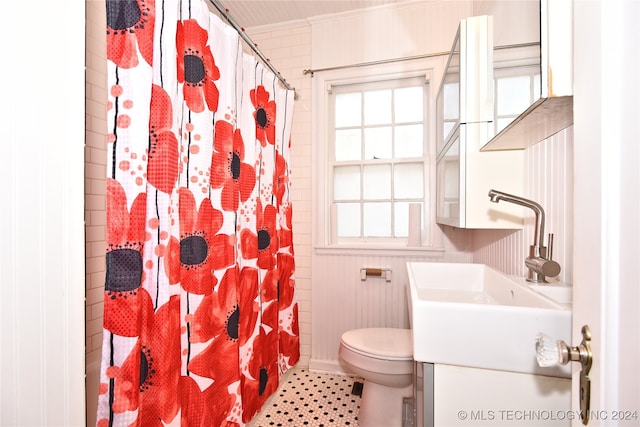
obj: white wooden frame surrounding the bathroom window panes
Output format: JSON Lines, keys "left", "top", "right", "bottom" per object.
{"left": 311, "top": 56, "right": 446, "bottom": 255}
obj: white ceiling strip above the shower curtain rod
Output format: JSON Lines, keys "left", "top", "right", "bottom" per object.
{"left": 211, "top": 0, "right": 415, "bottom": 28}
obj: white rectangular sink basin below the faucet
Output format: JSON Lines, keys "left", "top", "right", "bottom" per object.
{"left": 407, "top": 262, "right": 571, "bottom": 378}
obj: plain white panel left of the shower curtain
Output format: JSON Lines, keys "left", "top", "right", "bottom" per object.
{"left": 0, "top": 0, "right": 85, "bottom": 426}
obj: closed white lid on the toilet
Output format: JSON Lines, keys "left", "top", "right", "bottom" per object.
{"left": 342, "top": 328, "right": 413, "bottom": 359}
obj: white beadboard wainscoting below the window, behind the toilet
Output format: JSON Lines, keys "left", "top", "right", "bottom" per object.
{"left": 309, "top": 252, "right": 470, "bottom": 372}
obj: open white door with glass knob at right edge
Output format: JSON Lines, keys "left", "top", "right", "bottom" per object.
{"left": 571, "top": 0, "right": 640, "bottom": 426}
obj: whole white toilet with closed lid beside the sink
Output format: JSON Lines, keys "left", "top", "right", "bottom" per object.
{"left": 339, "top": 328, "right": 413, "bottom": 427}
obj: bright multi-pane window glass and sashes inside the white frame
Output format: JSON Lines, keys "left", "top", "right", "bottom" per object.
{"left": 328, "top": 76, "right": 428, "bottom": 243}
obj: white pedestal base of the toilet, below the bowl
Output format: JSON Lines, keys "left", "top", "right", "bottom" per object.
{"left": 358, "top": 380, "right": 413, "bottom": 427}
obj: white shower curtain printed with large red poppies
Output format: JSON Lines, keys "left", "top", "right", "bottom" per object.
{"left": 97, "top": 0, "right": 300, "bottom": 426}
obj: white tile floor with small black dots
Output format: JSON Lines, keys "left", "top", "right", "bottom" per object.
{"left": 249, "top": 367, "right": 362, "bottom": 427}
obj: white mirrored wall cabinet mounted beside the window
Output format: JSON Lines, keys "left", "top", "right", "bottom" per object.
{"left": 436, "top": 16, "right": 524, "bottom": 229}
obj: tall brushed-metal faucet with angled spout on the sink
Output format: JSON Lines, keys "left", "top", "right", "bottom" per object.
{"left": 489, "top": 190, "right": 560, "bottom": 283}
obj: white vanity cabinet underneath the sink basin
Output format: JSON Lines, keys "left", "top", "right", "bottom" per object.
{"left": 414, "top": 362, "right": 577, "bottom": 427}
